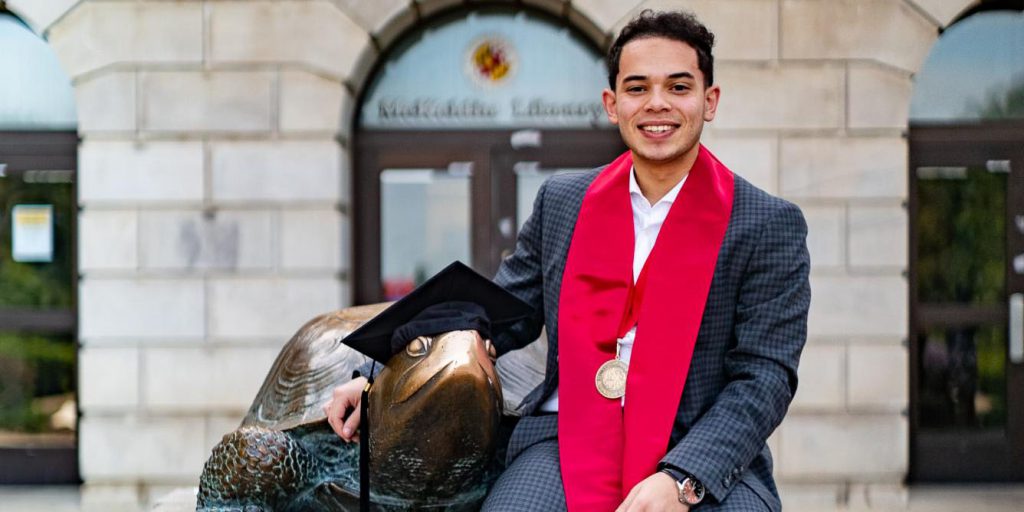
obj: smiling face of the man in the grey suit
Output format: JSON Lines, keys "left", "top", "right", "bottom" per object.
{"left": 602, "top": 37, "right": 720, "bottom": 170}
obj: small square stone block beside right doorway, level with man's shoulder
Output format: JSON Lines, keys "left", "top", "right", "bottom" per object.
{"left": 849, "top": 206, "right": 909, "bottom": 268}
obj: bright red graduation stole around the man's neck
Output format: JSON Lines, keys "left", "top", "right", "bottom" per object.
{"left": 558, "top": 145, "right": 733, "bottom": 511}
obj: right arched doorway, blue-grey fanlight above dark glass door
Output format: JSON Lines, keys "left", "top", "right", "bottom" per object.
{"left": 909, "top": 6, "right": 1024, "bottom": 481}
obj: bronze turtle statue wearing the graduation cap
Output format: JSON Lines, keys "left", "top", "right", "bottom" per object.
{"left": 197, "top": 304, "right": 503, "bottom": 512}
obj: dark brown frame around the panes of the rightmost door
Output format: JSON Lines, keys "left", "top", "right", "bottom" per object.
{"left": 907, "top": 121, "right": 1024, "bottom": 482}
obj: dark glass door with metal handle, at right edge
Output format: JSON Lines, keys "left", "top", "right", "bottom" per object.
{"left": 910, "top": 122, "right": 1024, "bottom": 481}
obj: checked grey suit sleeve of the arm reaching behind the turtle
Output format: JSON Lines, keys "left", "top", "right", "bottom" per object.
{"left": 493, "top": 181, "right": 548, "bottom": 355}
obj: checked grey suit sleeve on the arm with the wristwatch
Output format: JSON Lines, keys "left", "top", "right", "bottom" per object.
{"left": 662, "top": 203, "right": 811, "bottom": 502}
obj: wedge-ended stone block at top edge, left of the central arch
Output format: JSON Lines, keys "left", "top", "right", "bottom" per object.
{"left": 208, "top": 0, "right": 368, "bottom": 79}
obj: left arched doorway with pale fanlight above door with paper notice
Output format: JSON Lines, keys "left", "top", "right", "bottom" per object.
{"left": 0, "top": 8, "right": 79, "bottom": 484}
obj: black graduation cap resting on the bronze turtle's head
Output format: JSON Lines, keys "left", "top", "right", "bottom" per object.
{"left": 342, "top": 261, "right": 534, "bottom": 362}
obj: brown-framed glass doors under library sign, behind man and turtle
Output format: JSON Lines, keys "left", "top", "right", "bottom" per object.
{"left": 353, "top": 130, "right": 624, "bottom": 304}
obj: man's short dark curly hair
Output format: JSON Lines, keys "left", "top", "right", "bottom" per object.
{"left": 606, "top": 9, "right": 715, "bottom": 90}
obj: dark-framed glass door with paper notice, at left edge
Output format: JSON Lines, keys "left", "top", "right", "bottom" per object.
{"left": 0, "top": 132, "right": 78, "bottom": 483}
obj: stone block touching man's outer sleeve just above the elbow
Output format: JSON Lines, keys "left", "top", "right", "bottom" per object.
{"left": 808, "top": 274, "right": 907, "bottom": 338}
